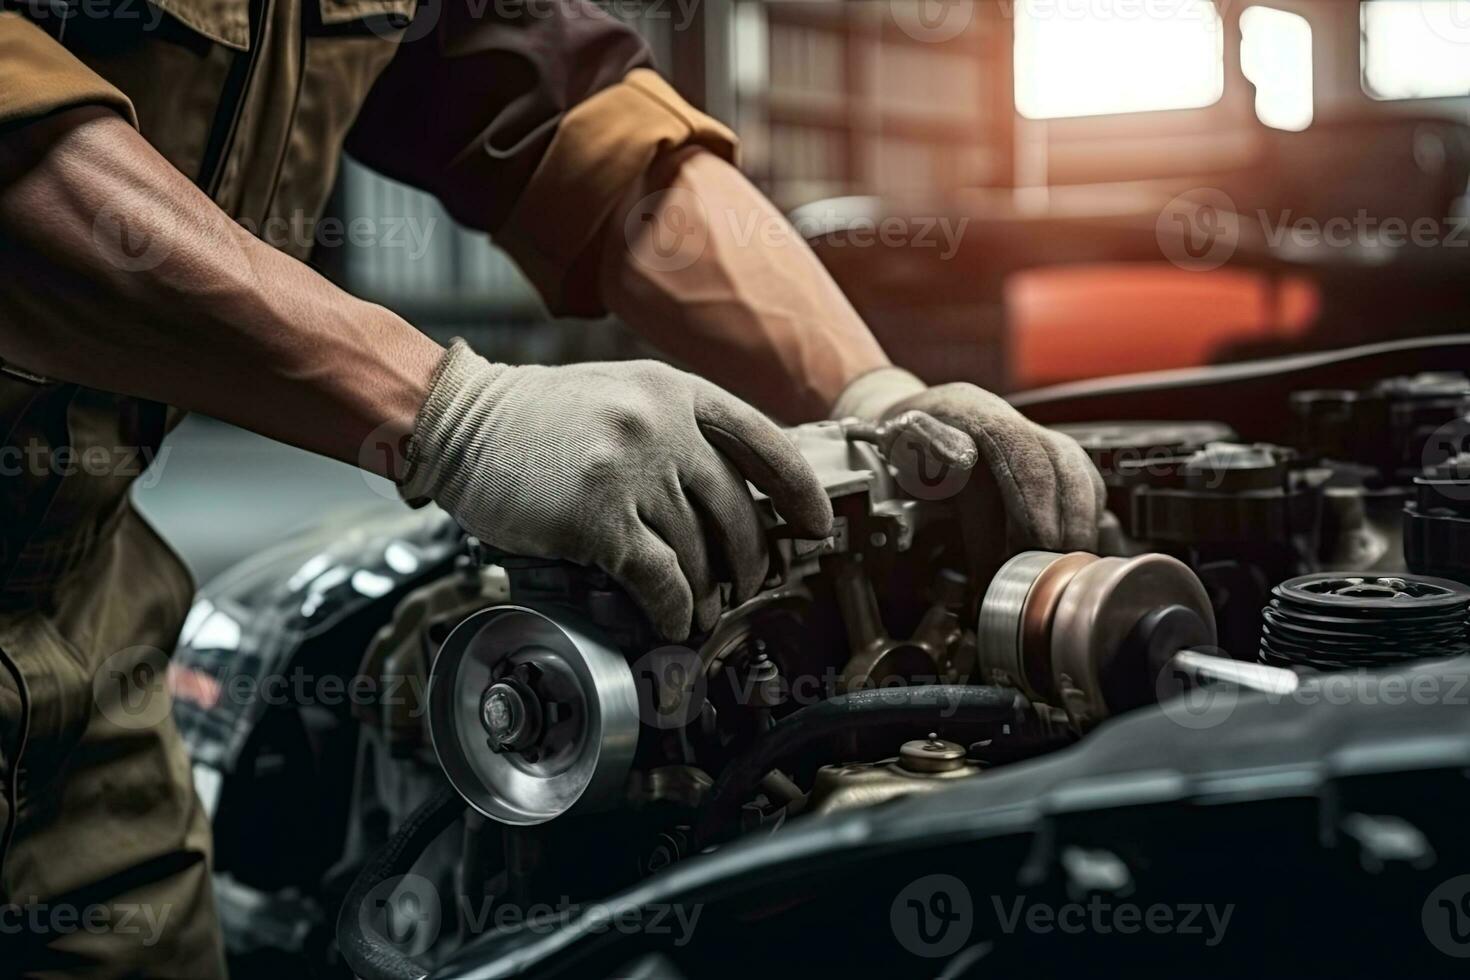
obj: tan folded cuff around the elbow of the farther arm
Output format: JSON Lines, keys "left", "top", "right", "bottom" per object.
{"left": 495, "top": 68, "right": 738, "bottom": 316}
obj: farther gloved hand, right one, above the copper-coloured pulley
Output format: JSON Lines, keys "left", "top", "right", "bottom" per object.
{"left": 832, "top": 367, "right": 1107, "bottom": 551}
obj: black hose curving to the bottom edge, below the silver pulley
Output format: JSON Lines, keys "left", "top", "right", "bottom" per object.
{"left": 337, "top": 786, "right": 465, "bottom": 980}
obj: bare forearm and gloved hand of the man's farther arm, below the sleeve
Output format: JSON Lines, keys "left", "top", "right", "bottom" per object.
{"left": 598, "top": 148, "right": 1104, "bottom": 550}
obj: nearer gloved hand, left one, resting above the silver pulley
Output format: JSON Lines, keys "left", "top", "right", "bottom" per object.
{"left": 400, "top": 341, "right": 832, "bottom": 641}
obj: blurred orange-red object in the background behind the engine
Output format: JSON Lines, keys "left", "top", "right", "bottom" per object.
{"left": 1005, "top": 263, "right": 1322, "bottom": 391}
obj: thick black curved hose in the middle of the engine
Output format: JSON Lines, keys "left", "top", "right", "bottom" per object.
{"left": 692, "top": 685, "right": 1029, "bottom": 851}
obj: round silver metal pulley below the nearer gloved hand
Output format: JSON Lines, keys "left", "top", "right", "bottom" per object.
{"left": 429, "top": 605, "right": 638, "bottom": 826}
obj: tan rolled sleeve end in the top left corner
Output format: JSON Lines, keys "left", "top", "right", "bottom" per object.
{"left": 0, "top": 12, "right": 138, "bottom": 126}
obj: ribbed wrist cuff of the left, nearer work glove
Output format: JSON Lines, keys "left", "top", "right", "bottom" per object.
{"left": 398, "top": 338, "right": 506, "bottom": 507}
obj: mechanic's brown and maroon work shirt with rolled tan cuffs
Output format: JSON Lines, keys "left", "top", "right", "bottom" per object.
{"left": 0, "top": 0, "right": 734, "bottom": 605}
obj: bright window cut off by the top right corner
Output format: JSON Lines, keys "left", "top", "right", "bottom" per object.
{"left": 1361, "top": 0, "right": 1470, "bottom": 98}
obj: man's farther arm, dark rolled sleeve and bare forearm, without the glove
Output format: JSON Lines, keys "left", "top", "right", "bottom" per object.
{"left": 347, "top": 0, "right": 888, "bottom": 422}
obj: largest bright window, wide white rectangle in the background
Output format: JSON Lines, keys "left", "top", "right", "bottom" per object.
{"left": 1014, "top": 0, "right": 1225, "bottom": 119}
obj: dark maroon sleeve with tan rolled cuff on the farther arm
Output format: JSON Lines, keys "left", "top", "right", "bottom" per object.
{"left": 347, "top": 0, "right": 735, "bottom": 316}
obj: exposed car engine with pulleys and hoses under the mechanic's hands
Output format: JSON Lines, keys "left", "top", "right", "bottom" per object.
{"left": 172, "top": 362, "right": 1470, "bottom": 976}
